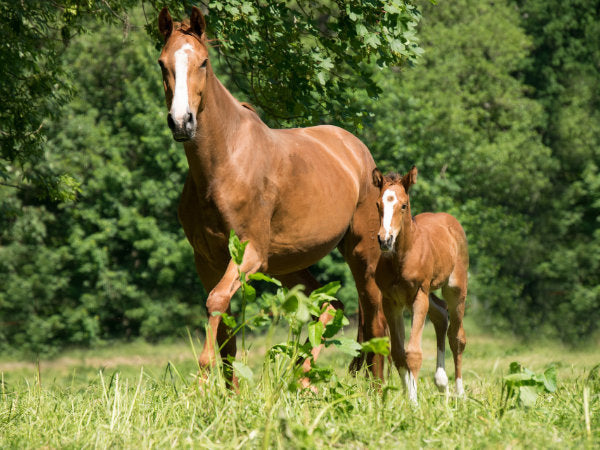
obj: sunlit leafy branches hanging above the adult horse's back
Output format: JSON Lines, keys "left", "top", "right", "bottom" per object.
{"left": 149, "top": 0, "right": 420, "bottom": 129}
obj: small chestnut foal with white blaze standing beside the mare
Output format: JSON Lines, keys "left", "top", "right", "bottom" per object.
{"left": 373, "top": 166, "right": 469, "bottom": 403}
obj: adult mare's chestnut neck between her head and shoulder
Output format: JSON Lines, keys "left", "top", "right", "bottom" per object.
{"left": 184, "top": 70, "right": 256, "bottom": 189}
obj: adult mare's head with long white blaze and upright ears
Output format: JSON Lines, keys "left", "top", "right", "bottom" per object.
{"left": 158, "top": 6, "right": 209, "bottom": 141}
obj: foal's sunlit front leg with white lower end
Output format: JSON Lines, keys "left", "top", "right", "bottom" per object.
{"left": 404, "top": 288, "right": 429, "bottom": 404}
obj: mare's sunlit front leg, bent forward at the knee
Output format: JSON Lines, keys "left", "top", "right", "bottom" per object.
{"left": 198, "top": 242, "right": 263, "bottom": 369}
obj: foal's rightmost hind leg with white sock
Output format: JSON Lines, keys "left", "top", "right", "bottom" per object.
{"left": 442, "top": 286, "right": 467, "bottom": 395}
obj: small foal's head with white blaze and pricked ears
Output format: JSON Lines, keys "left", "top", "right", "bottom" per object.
{"left": 373, "top": 166, "right": 417, "bottom": 251}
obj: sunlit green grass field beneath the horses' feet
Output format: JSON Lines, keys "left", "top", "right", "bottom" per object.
{"left": 0, "top": 321, "right": 600, "bottom": 448}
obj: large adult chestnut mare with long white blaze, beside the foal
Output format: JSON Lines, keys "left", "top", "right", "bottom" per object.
{"left": 158, "top": 7, "right": 385, "bottom": 378}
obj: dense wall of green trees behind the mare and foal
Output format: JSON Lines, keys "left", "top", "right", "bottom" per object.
{"left": 0, "top": 0, "right": 600, "bottom": 351}
